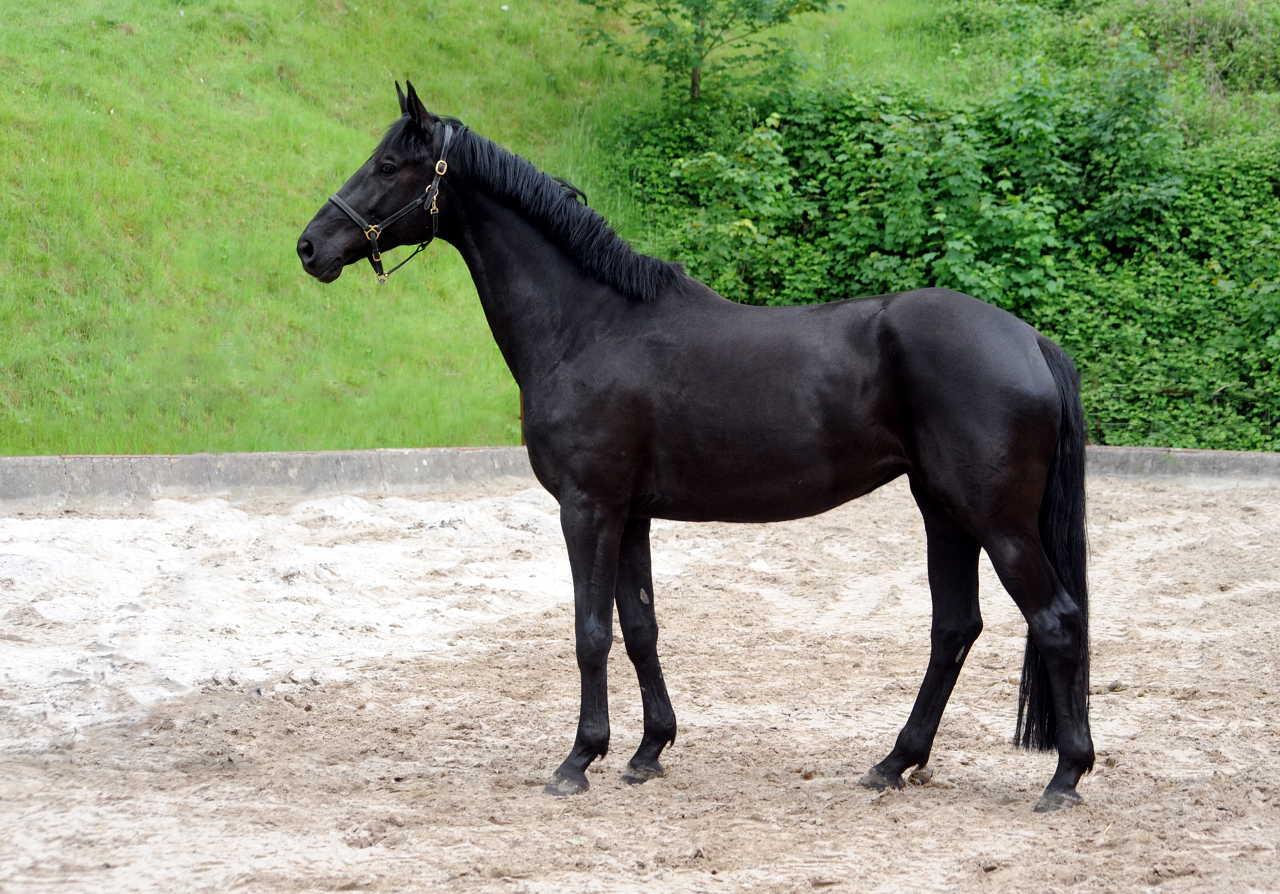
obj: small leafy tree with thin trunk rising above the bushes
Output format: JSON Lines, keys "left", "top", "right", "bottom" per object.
{"left": 580, "top": 0, "right": 842, "bottom": 102}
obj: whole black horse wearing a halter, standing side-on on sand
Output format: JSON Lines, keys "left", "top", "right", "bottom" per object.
{"left": 298, "top": 85, "right": 1093, "bottom": 811}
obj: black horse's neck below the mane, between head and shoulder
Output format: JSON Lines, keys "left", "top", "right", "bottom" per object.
{"left": 449, "top": 195, "right": 622, "bottom": 387}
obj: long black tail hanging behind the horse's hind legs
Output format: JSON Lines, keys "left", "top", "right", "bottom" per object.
{"left": 1014, "top": 337, "right": 1089, "bottom": 751}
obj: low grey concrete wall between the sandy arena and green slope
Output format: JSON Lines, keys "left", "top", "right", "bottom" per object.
{"left": 0, "top": 447, "right": 1280, "bottom": 511}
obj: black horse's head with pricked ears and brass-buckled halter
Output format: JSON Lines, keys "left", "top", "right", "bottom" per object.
{"left": 298, "top": 83, "right": 457, "bottom": 283}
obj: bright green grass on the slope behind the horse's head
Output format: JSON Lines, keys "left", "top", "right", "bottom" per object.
{"left": 0, "top": 0, "right": 942, "bottom": 453}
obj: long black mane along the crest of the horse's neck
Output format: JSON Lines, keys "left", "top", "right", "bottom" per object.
{"left": 383, "top": 115, "right": 685, "bottom": 301}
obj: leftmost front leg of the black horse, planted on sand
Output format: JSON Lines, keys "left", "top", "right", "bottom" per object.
{"left": 543, "top": 496, "right": 626, "bottom": 795}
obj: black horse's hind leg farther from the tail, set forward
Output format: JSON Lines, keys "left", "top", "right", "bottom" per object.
{"left": 860, "top": 478, "right": 982, "bottom": 790}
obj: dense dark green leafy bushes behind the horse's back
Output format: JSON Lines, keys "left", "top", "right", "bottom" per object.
{"left": 606, "top": 24, "right": 1280, "bottom": 450}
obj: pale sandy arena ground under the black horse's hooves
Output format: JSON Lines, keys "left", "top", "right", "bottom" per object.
{"left": 0, "top": 480, "right": 1280, "bottom": 894}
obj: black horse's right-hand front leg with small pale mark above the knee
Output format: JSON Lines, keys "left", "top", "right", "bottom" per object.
{"left": 614, "top": 519, "right": 676, "bottom": 783}
